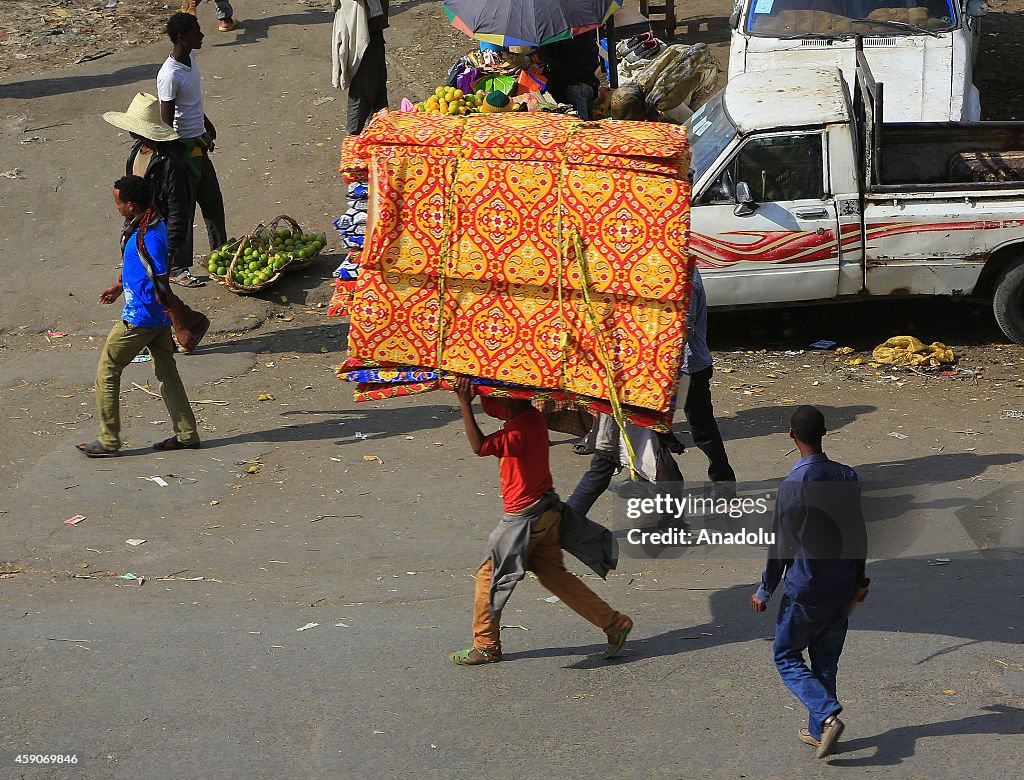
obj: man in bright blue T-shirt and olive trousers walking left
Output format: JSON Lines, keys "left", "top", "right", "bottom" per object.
{"left": 77, "top": 176, "right": 200, "bottom": 458}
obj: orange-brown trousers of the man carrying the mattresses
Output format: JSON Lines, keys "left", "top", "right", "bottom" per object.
{"left": 473, "top": 512, "right": 631, "bottom": 653}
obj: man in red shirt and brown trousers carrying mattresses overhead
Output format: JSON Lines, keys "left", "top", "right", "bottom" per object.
{"left": 449, "top": 377, "right": 633, "bottom": 666}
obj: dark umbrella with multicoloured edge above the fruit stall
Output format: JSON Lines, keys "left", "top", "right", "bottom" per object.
{"left": 444, "top": 0, "right": 624, "bottom": 46}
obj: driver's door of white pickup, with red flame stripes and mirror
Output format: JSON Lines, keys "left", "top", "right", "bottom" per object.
{"left": 690, "top": 130, "right": 840, "bottom": 306}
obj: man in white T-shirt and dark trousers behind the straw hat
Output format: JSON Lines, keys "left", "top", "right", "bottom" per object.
{"left": 157, "top": 13, "right": 227, "bottom": 287}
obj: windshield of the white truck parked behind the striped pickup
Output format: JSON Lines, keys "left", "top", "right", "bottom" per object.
{"left": 746, "top": 0, "right": 956, "bottom": 38}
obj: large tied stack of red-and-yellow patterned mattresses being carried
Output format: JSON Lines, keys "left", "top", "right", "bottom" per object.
{"left": 342, "top": 112, "right": 692, "bottom": 421}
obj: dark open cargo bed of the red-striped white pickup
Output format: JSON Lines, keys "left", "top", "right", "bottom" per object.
{"left": 869, "top": 122, "right": 1024, "bottom": 192}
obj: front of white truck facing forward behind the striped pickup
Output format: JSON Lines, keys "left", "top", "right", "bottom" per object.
{"left": 729, "top": 0, "right": 988, "bottom": 122}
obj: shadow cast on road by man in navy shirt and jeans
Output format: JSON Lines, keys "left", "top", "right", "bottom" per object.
{"left": 828, "top": 704, "right": 1024, "bottom": 767}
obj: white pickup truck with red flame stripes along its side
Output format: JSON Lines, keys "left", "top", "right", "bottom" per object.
{"left": 687, "top": 45, "right": 1024, "bottom": 344}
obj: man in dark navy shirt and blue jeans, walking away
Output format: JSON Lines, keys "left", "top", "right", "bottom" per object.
{"left": 751, "top": 406, "right": 867, "bottom": 759}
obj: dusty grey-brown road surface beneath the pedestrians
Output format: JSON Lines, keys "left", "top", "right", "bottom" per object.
{"left": 0, "top": 0, "right": 1024, "bottom": 780}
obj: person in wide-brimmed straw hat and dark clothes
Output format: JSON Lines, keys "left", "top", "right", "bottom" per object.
{"left": 103, "top": 92, "right": 196, "bottom": 288}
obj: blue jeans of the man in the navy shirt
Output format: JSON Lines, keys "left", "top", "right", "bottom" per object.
{"left": 774, "top": 596, "right": 850, "bottom": 739}
